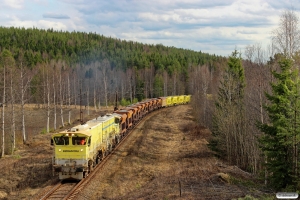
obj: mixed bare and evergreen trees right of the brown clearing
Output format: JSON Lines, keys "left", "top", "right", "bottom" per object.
{"left": 191, "top": 11, "right": 300, "bottom": 192}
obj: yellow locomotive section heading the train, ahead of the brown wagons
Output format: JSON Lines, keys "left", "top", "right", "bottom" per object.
{"left": 52, "top": 115, "right": 120, "bottom": 180}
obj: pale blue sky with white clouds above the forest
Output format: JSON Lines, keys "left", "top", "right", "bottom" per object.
{"left": 0, "top": 0, "right": 300, "bottom": 56}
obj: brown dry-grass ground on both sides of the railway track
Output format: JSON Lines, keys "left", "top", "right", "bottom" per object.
{"left": 0, "top": 105, "right": 274, "bottom": 200}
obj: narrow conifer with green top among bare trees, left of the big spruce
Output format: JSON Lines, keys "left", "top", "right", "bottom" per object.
{"left": 211, "top": 50, "right": 247, "bottom": 168}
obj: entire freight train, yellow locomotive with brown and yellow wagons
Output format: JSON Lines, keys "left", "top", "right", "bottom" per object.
{"left": 51, "top": 95, "right": 191, "bottom": 180}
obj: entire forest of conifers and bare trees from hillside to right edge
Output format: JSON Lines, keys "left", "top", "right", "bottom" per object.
{"left": 0, "top": 8, "right": 300, "bottom": 191}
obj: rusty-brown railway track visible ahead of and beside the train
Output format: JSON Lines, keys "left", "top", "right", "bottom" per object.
{"left": 40, "top": 110, "right": 157, "bottom": 200}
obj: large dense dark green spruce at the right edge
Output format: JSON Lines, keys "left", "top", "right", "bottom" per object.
{"left": 258, "top": 59, "right": 300, "bottom": 190}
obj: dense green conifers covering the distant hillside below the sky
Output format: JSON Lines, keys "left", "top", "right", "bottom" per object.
{"left": 0, "top": 27, "right": 221, "bottom": 70}
